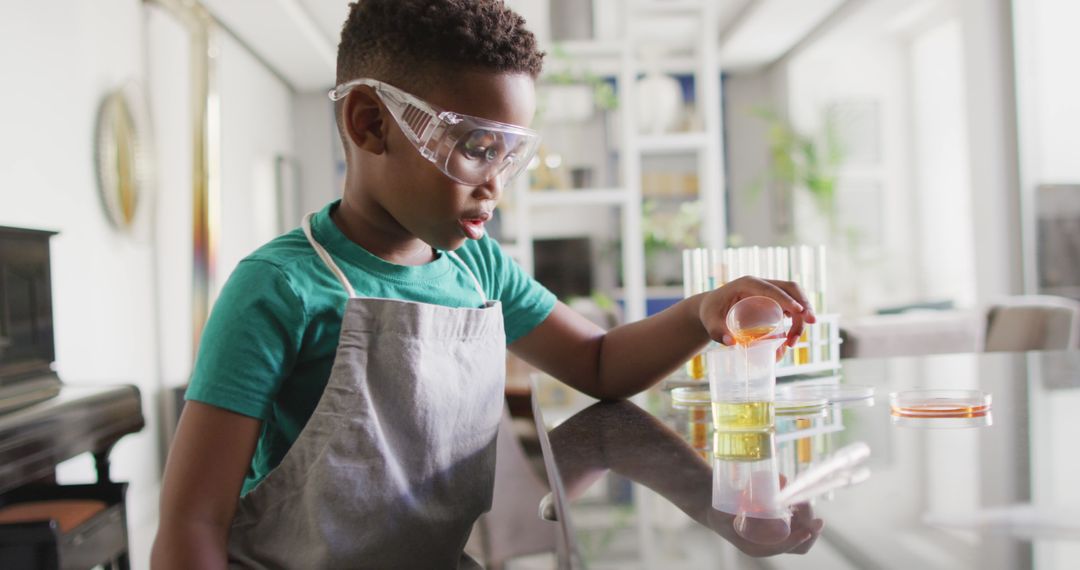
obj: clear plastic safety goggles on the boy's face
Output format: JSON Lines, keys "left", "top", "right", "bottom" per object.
{"left": 329, "top": 79, "right": 540, "bottom": 186}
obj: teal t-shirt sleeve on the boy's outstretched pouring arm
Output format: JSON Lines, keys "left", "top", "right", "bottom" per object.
{"left": 482, "top": 238, "right": 556, "bottom": 344}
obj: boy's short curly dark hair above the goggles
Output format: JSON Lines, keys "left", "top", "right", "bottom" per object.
{"left": 337, "top": 0, "right": 544, "bottom": 96}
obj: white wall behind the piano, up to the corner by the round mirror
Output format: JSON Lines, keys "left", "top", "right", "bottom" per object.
{"left": 0, "top": 0, "right": 159, "bottom": 558}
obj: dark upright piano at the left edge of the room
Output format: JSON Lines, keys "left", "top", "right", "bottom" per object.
{"left": 0, "top": 227, "right": 145, "bottom": 569}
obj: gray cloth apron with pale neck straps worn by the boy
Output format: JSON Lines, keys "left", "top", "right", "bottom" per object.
{"left": 228, "top": 214, "right": 505, "bottom": 569}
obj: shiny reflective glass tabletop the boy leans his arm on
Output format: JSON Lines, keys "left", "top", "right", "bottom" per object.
{"left": 534, "top": 352, "right": 1080, "bottom": 569}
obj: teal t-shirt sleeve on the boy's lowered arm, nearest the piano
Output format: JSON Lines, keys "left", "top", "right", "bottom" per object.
{"left": 186, "top": 259, "right": 305, "bottom": 420}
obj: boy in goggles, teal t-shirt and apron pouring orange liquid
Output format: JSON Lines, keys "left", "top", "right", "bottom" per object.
{"left": 152, "top": 0, "right": 813, "bottom": 568}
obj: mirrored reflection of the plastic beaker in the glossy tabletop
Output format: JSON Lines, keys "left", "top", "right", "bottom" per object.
{"left": 713, "top": 431, "right": 791, "bottom": 544}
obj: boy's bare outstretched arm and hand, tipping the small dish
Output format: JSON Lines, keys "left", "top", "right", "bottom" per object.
{"left": 510, "top": 277, "right": 814, "bottom": 399}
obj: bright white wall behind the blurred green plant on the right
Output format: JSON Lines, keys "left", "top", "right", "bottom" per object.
{"left": 783, "top": 2, "right": 919, "bottom": 315}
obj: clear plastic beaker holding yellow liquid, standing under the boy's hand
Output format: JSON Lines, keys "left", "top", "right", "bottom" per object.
{"left": 706, "top": 339, "right": 784, "bottom": 431}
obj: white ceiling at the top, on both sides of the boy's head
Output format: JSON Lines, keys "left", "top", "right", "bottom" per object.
{"left": 196, "top": 0, "right": 859, "bottom": 92}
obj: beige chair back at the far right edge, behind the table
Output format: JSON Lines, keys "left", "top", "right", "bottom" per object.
{"left": 985, "top": 295, "right": 1080, "bottom": 352}
